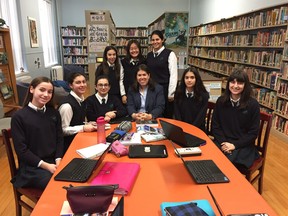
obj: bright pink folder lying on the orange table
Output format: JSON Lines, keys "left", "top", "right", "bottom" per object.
{"left": 91, "top": 162, "right": 140, "bottom": 195}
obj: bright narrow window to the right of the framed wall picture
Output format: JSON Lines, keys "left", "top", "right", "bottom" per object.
{"left": 39, "top": 0, "right": 58, "bottom": 67}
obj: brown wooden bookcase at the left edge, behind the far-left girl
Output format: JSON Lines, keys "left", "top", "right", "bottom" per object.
{"left": 0, "top": 28, "right": 18, "bottom": 113}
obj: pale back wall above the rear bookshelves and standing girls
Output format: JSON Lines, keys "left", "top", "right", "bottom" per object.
{"left": 57, "top": 0, "right": 190, "bottom": 27}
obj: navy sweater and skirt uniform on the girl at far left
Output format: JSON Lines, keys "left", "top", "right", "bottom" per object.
{"left": 11, "top": 106, "right": 63, "bottom": 189}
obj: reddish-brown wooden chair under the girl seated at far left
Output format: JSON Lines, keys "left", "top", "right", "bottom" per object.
{"left": 2, "top": 129, "right": 43, "bottom": 216}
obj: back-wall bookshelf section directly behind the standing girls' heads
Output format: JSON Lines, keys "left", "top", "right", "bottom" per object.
{"left": 116, "top": 27, "right": 149, "bottom": 57}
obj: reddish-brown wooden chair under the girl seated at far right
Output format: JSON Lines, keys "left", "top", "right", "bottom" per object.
{"left": 237, "top": 112, "right": 272, "bottom": 194}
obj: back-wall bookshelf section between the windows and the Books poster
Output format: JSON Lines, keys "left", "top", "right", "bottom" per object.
{"left": 60, "top": 26, "right": 88, "bottom": 73}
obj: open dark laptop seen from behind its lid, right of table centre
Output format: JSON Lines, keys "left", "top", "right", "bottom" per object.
{"left": 159, "top": 119, "right": 206, "bottom": 147}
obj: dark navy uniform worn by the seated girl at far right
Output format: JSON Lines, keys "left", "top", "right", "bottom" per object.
{"left": 212, "top": 97, "right": 260, "bottom": 168}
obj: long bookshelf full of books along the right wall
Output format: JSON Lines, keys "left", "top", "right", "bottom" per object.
{"left": 188, "top": 4, "right": 288, "bottom": 138}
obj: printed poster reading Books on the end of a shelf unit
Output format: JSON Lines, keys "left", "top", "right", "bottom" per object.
{"left": 88, "top": 24, "right": 109, "bottom": 52}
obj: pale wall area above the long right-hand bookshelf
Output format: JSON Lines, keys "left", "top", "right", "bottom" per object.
{"left": 190, "top": 0, "right": 288, "bottom": 26}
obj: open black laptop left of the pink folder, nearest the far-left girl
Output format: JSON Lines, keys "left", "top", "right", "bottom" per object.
{"left": 54, "top": 143, "right": 112, "bottom": 182}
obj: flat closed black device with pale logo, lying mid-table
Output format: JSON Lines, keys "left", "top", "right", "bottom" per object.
{"left": 128, "top": 144, "right": 168, "bottom": 158}
